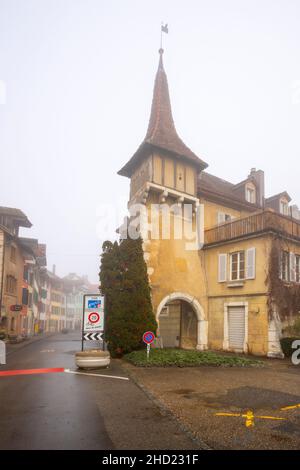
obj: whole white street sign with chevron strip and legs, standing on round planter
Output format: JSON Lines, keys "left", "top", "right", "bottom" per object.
{"left": 81, "top": 294, "right": 105, "bottom": 351}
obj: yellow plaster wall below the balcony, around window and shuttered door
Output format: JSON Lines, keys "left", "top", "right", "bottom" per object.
{"left": 205, "top": 236, "right": 271, "bottom": 355}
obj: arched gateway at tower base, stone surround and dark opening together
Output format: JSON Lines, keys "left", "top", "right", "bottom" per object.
{"left": 156, "top": 292, "right": 208, "bottom": 351}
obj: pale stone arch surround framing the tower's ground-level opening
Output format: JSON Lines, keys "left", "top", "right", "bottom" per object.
{"left": 156, "top": 292, "right": 208, "bottom": 351}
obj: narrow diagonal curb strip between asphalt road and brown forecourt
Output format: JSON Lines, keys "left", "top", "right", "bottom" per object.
{"left": 120, "top": 361, "right": 213, "bottom": 450}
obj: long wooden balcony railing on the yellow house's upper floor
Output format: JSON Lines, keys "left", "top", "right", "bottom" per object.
{"left": 204, "top": 209, "right": 300, "bottom": 244}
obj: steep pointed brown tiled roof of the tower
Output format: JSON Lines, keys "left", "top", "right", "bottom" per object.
{"left": 118, "top": 49, "right": 208, "bottom": 177}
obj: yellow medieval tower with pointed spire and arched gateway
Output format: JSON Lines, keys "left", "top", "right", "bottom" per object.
{"left": 119, "top": 49, "right": 207, "bottom": 349}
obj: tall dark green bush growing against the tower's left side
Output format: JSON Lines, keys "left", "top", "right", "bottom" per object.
{"left": 100, "top": 238, "right": 157, "bottom": 355}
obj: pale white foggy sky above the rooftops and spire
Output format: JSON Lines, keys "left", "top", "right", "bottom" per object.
{"left": 0, "top": 0, "right": 300, "bottom": 282}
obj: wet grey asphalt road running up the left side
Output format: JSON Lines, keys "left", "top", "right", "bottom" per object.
{"left": 0, "top": 333, "right": 197, "bottom": 450}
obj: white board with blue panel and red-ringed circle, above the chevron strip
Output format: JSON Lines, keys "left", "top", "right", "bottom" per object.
{"left": 83, "top": 294, "right": 104, "bottom": 333}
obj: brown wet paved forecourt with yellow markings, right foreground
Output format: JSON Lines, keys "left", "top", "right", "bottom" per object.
{"left": 123, "top": 360, "right": 300, "bottom": 449}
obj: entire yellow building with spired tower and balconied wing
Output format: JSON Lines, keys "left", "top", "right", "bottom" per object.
{"left": 119, "top": 50, "right": 300, "bottom": 357}
